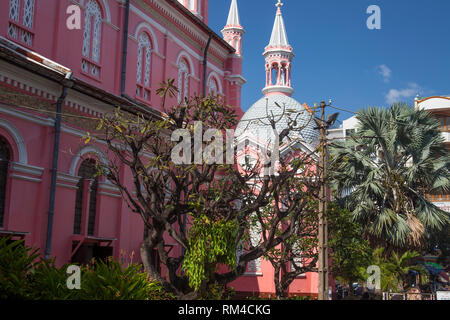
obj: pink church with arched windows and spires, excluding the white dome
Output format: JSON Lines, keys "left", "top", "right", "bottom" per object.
{"left": 0, "top": 0, "right": 317, "bottom": 294}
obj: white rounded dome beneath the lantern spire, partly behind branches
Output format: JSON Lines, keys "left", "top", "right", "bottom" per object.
{"left": 236, "top": 94, "right": 319, "bottom": 147}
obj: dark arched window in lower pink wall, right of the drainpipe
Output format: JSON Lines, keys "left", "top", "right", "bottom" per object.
{"left": 73, "top": 159, "right": 98, "bottom": 235}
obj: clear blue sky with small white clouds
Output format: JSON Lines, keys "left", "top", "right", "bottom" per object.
{"left": 209, "top": 0, "right": 450, "bottom": 119}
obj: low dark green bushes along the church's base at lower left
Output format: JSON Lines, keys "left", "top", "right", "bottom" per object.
{"left": 0, "top": 238, "right": 173, "bottom": 300}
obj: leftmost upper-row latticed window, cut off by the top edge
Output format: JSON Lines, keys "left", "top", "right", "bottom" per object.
{"left": 8, "top": 0, "right": 35, "bottom": 47}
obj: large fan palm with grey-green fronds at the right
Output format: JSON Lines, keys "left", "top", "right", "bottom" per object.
{"left": 330, "top": 104, "right": 450, "bottom": 249}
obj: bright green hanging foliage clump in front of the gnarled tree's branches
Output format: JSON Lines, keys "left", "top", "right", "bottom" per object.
{"left": 183, "top": 216, "right": 238, "bottom": 290}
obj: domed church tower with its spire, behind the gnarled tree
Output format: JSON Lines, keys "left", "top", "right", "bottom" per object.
{"left": 234, "top": 1, "right": 326, "bottom": 297}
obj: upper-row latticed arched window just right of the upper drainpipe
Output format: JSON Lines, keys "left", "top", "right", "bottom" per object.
{"left": 136, "top": 32, "right": 152, "bottom": 99}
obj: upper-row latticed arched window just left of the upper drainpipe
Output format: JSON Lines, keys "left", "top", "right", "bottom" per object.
{"left": 81, "top": 0, "right": 102, "bottom": 77}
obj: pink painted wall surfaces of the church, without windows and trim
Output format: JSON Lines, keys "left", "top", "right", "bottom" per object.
{"left": 0, "top": 0, "right": 316, "bottom": 298}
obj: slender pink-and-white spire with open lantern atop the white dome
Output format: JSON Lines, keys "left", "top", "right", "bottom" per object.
{"left": 263, "top": 0, "right": 294, "bottom": 96}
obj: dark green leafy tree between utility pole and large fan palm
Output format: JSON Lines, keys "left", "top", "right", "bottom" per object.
{"left": 328, "top": 203, "right": 372, "bottom": 283}
